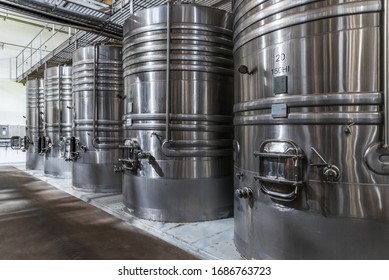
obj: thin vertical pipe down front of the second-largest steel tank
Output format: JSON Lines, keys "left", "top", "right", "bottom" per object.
{"left": 165, "top": 0, "right": 171, "bottom": 142}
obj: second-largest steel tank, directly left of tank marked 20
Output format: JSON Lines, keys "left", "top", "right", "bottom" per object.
{"left": 121, "top": 4, "right": 233, "bottom": 222}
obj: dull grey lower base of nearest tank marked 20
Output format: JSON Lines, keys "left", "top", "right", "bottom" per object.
{"left": 234, "top": 201, "right": 389, "bottom": 260}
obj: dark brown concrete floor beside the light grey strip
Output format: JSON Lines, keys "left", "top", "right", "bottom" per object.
{"left": 0, "top": 166, "right": 196, "bottom": 260}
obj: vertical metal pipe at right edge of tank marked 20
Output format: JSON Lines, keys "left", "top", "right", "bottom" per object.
{"left": 382, "top": 0, "right": 389, "bottom": 148}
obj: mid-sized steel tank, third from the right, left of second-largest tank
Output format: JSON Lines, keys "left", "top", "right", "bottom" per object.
{"left": 69, "top": 44, "right": 123, "bottom": 192}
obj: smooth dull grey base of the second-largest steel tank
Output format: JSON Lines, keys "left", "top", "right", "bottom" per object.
{"left": 123, "top": 174, "right": 233, "bottom": 223}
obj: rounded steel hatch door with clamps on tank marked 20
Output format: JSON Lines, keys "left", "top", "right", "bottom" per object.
{"left": 254, "top": 139, "right": 304, "bottom": 201}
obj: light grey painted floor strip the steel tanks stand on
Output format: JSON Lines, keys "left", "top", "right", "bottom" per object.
{"left": 14, "top": 164, "right": 241, "bottom": 260}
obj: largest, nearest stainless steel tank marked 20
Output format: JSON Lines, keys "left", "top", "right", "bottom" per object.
{"left": 233, "top": 0, "right": 389, "bottom": 259}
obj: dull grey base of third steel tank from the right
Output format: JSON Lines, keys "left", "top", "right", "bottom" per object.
{"left": 72, "top": 162, "right": 122, "bottom": 193}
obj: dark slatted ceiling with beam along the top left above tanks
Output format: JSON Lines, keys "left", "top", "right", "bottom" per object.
{"left": 0, "top": 0, "right": 231, "bottom": 39}
